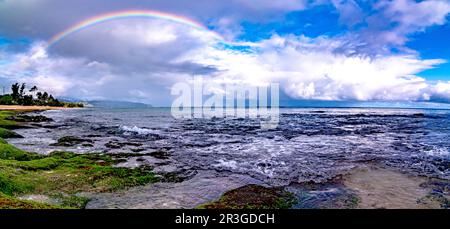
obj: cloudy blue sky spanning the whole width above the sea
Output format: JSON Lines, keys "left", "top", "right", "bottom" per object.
{"left": 0, "top": 0, "right": 450, "bottom": 105}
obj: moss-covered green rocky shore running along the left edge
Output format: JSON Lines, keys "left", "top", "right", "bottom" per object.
{"left": 0, "top": 111, "right": 181, "bottom": 208}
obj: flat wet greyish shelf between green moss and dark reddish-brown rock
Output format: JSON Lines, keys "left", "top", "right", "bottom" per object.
{"left": 86, "top": 171, "right": 262, "bottom": 209}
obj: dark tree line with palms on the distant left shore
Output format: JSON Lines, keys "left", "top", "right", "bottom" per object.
{"left": 0, "top": 83, "right": 83, "bottom": 107}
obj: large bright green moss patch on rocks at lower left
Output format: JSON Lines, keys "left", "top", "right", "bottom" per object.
{"left": 0, "top": 139, "right": 159, "bottom": 208}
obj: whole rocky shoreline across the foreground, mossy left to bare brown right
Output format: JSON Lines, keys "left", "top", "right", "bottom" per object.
{"left": 0, "top": 110, "right": 450, "bottom": 209}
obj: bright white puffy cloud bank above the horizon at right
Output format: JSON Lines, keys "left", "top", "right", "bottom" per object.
{"left": 191, "top": 33, "right": 448, "bottom": 101}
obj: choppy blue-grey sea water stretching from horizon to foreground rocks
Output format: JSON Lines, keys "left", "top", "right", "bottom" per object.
{"left": 11, "top": 108, "right": 450, "bottom": 185}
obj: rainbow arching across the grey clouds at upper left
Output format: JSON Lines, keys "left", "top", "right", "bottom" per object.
{"left": 47, "top": 10, "right": 224, "bottom": 47}
